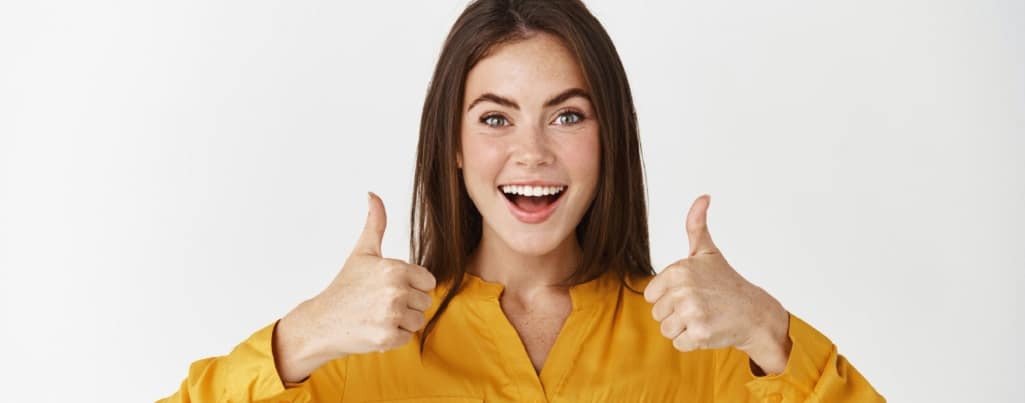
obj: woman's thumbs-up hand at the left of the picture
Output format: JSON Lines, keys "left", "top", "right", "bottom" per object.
{"left": 274, "top": 193, "right": 437, "bottom": 381}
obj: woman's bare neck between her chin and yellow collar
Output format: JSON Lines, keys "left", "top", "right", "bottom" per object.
{"left": 466, "top": 224, "right": 582, "bottom": 299}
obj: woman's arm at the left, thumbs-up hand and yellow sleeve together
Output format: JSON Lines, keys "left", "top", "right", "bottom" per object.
{"left": 157, "top": 193, "right": 437, "bottom": 402}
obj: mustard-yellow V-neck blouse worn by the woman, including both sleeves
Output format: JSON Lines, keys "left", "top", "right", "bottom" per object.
{"left": 162, "top": 272, "right": 886, "bottom": 403}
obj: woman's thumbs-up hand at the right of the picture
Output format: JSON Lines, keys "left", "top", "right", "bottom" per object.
{"left": 644, "top": 195, "right": 790, "bottom": 373}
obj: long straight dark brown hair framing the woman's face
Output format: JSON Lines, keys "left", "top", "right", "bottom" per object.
{"left": 409, "top": 0, "right": 655, "bottom": 353}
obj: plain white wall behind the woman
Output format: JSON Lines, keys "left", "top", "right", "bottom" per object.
{"left": 0, "top": 0, "right": 1025, "bottom": 402}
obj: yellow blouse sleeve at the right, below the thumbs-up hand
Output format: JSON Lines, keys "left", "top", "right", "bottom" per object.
{"left": 714, "top": 314, "right": 886, "bottom": 402}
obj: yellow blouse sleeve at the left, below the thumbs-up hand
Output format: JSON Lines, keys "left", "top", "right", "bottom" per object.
{"left": 158, "top": 321, "right": 345, "bottom": 403}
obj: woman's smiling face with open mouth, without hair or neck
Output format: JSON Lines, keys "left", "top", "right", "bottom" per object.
{"left": 457, "top": 33, "right": 601, "bottom": 255}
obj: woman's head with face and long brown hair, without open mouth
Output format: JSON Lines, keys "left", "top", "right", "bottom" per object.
{"left": 410, "top": 0, "right": 654, "bottom": 348}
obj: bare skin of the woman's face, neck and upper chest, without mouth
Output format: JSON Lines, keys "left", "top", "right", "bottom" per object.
{"left": 456, "top": 34, "right": 601, "bottom": 371}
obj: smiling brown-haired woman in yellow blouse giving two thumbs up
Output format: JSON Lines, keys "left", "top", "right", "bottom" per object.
{"left": 159, "top": 0, "right": 883, "bottom": 402}
